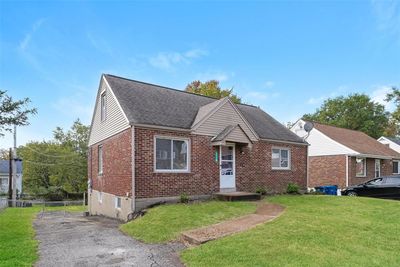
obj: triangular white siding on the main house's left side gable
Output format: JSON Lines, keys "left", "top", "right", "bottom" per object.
{"left": 89, "top": 77, "right": 130, "bottom": 146}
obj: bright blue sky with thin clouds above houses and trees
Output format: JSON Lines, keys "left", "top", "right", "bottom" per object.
{"left": 0, "top": 1, "right": 400, "bottom": 148}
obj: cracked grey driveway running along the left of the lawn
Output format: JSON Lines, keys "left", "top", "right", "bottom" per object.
{"left": 34, "top": 211, "right": 184, "bottom": 266}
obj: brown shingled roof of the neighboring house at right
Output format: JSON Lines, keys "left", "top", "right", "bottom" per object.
{"left": 313, "top": 122, "right": 400, "bottom": 158}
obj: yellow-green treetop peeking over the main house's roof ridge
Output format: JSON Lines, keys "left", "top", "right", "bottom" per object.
{"left": 185, "top": 80, "right": 242, "bottom": 104}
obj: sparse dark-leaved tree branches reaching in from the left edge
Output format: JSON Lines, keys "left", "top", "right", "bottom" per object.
{"left": 0, "top": 90, "right": 37, "bottom": 136}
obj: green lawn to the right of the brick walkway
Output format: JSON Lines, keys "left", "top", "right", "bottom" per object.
{"left": 181, "top": 196, "right": 400, "bottom": 267}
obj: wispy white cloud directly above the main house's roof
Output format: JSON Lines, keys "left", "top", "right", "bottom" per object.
{"left": 148, "top": 49, "right": 208, "bottom": 71}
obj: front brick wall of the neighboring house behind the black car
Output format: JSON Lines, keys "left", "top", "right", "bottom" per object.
{"left": 349, "top": 157, "right": 393, "bottom": 185}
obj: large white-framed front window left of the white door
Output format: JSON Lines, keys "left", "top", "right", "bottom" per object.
{"left": 155, "top": 137, "right": 189, "bottom": 171}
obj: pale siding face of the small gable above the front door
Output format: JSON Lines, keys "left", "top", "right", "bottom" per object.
{"left": 193, "top": 98, "right": 258, "bottom": 141}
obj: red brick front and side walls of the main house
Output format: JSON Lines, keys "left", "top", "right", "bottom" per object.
{"left": 89, "top": 127, "right": 307, "bottom": 198}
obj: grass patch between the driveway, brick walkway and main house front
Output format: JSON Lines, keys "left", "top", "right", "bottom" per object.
{"left": 121, "top": 201, "right": 256, "bottom": 243}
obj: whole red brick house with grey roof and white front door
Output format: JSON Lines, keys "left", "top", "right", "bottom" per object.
{"left": 88, "top": 75, "right": 307, "bottom": 219}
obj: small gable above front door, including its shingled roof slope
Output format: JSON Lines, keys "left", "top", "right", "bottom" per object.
{"left": 192, "top": 97, "right": 258, "bottom": 142}
